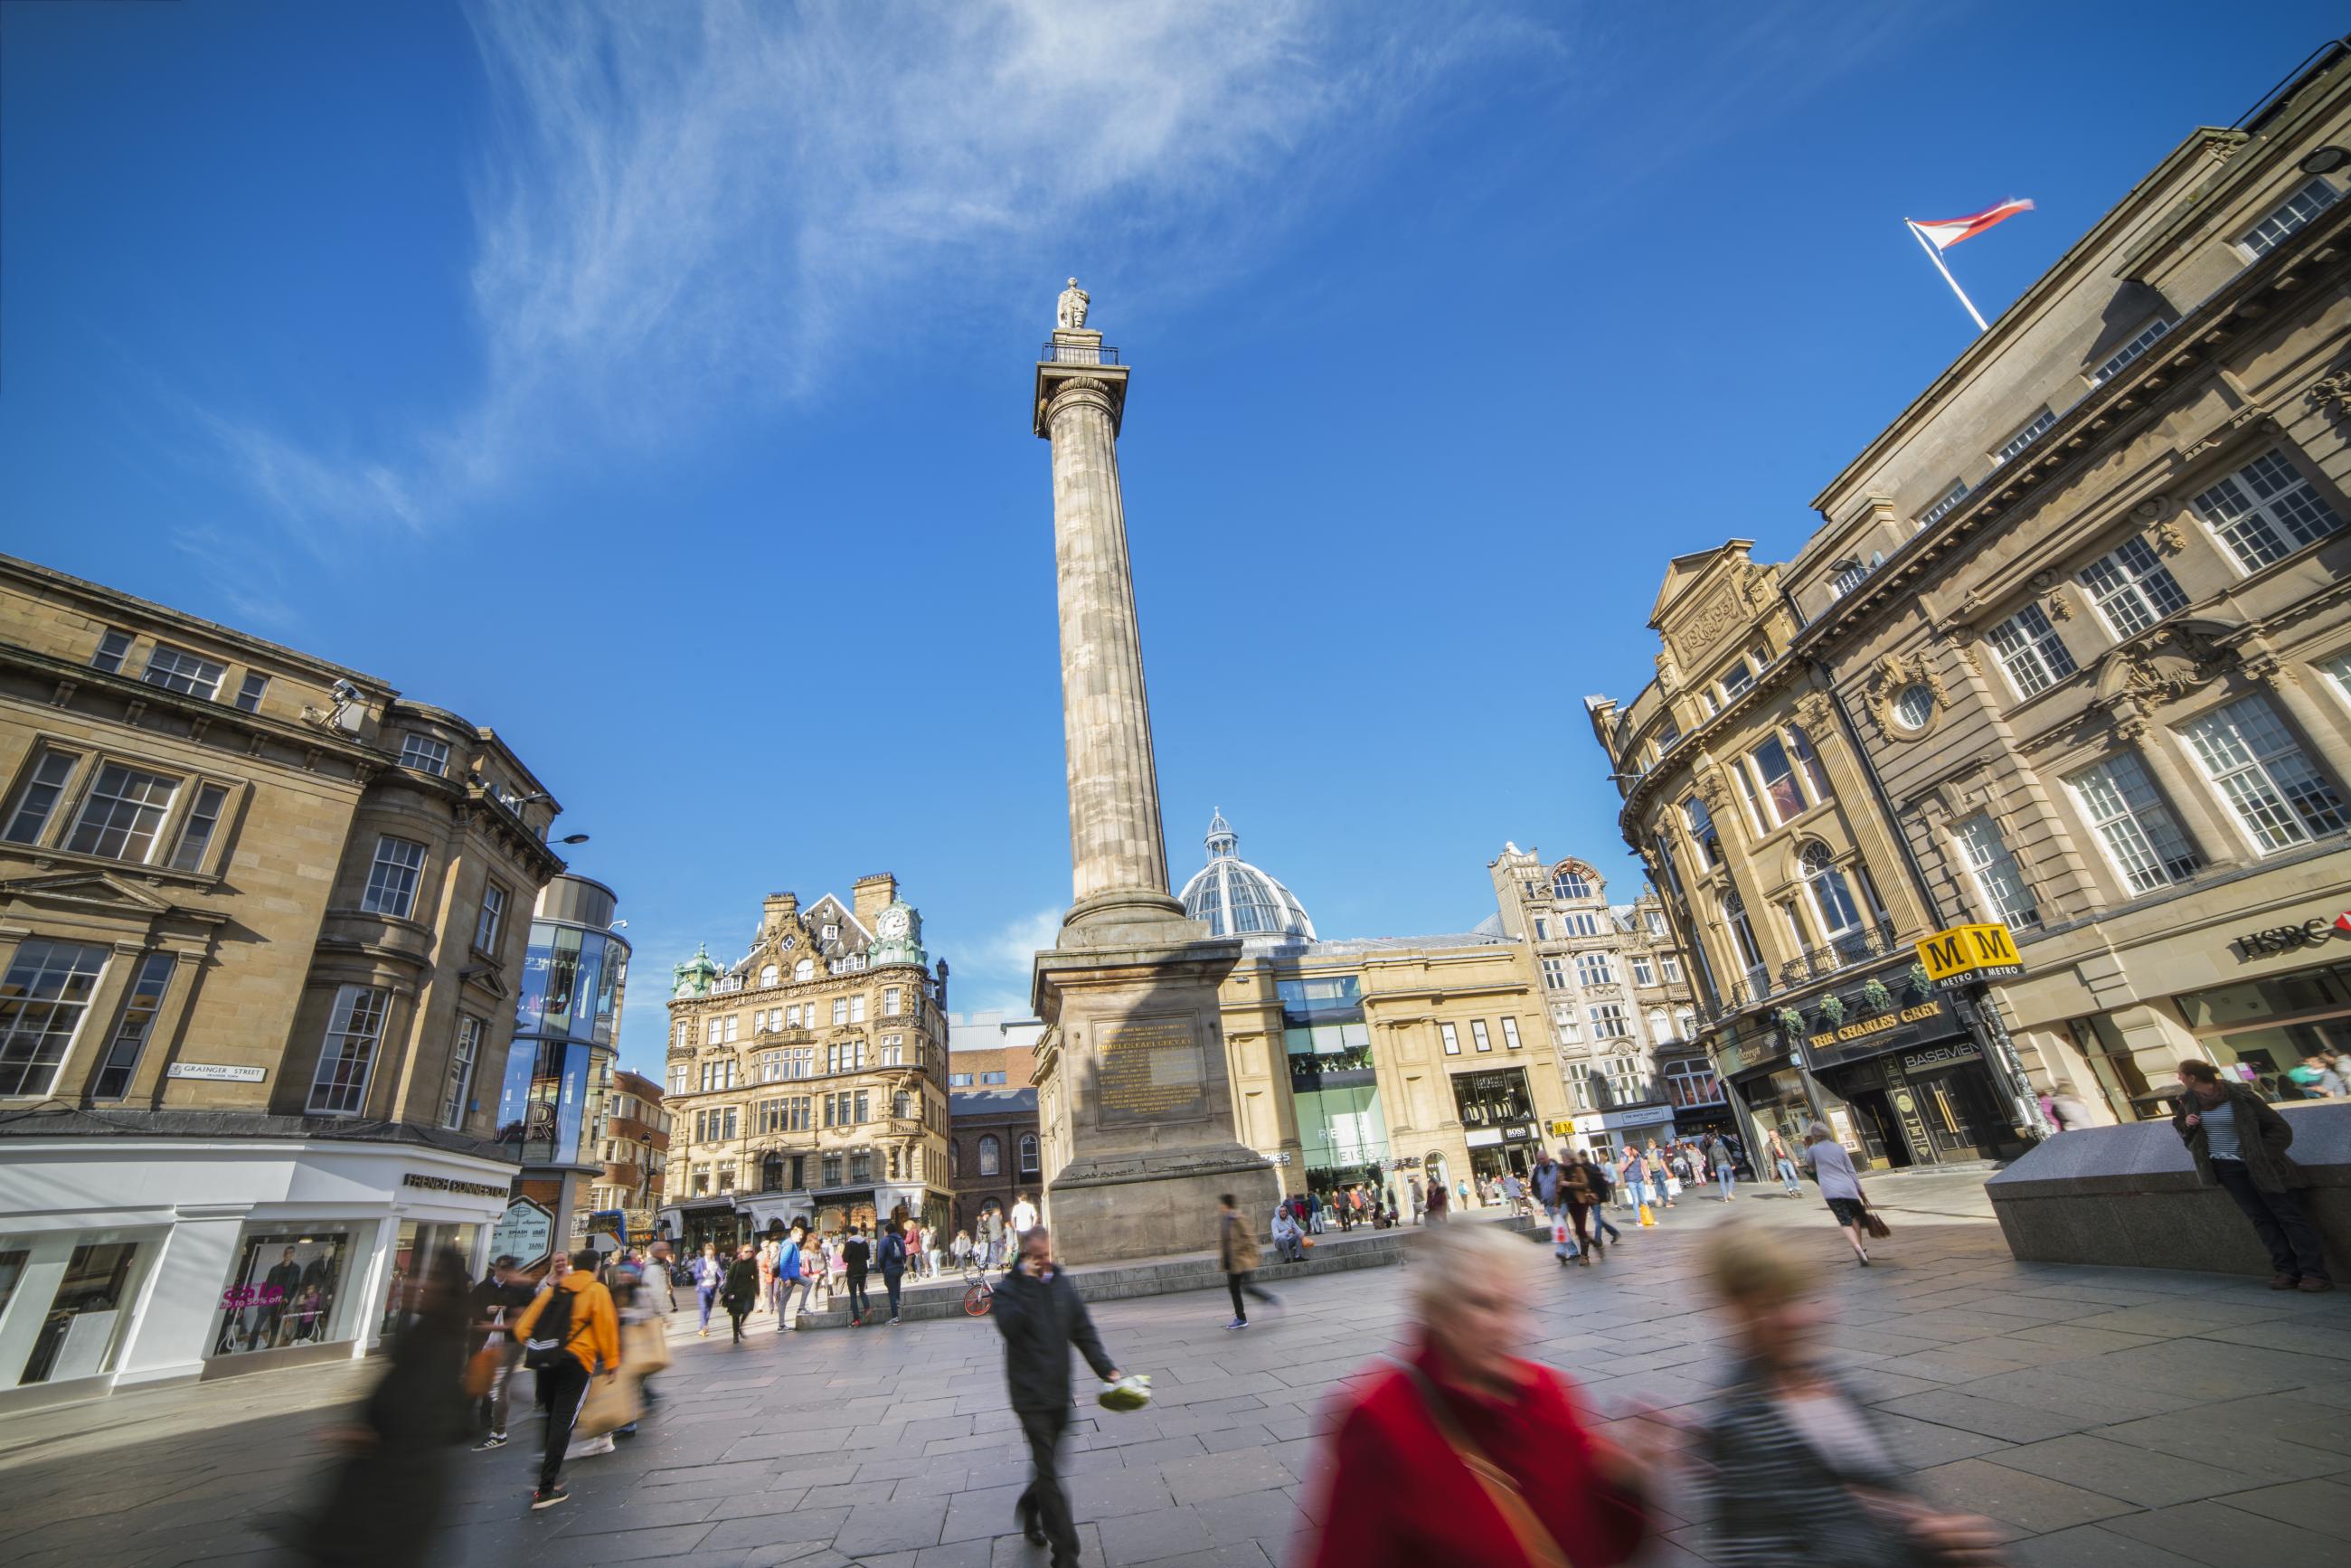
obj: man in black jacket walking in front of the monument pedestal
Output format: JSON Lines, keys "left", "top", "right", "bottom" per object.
{"left": 992, "top": 1224, "right": 1119, "bottom": 1568}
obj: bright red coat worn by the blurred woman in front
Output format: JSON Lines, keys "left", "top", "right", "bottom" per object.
{"left": 1298, "top": 1342, "right": 1648, "bottom": 1568}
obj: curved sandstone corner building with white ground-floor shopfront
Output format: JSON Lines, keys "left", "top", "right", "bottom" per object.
{"left": 0, "top": 557, "right": 562, "bottom": 1408}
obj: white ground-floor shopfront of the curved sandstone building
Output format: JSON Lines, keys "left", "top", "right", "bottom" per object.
{"left": 0, "top": 1136, "right": 515, "bottom": 1412}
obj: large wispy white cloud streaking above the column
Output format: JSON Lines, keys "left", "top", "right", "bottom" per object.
{"left": 193, "top": 0, "right": 1556, "bottom": 534}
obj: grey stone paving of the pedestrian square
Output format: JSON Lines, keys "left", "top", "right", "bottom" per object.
{"left": 0, "top": 1176, "right": 2351, "bottom": 1568}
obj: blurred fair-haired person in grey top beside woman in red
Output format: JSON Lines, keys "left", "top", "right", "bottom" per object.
{"left": 1697, "top": 1224, "right": 1998, "bottom": 1568}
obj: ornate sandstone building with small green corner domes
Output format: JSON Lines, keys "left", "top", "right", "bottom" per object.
{"left": 661, "top": 874, "right": 949, "bottom": 1248}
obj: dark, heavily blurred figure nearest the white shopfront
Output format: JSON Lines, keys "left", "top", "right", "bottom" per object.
{"left": 287, "top": 1246, "right": 470, "bottom": 1568}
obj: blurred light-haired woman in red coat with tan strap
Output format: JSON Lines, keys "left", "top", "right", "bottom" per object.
{"left": 1298, "top": 1224, "right": 1648, "bottom": 1568}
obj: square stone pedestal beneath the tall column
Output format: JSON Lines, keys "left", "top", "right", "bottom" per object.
{"left": 1032, "top": 912, "right": 1281, "bottom": 1262}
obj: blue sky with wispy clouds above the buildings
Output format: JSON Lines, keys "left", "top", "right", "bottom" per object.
{"left": 0, "top": 0, "right": 2342, "bottom": 1067}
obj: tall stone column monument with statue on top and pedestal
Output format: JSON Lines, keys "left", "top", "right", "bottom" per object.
{"left": 1032, "top": 278, "right": 1279, "bottom": 1262}
